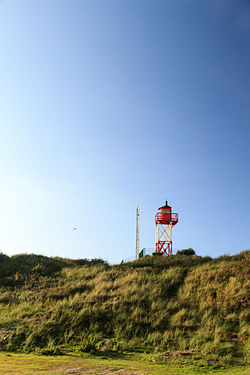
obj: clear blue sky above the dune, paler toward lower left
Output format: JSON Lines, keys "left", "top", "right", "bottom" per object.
{"left": 0, "top": 0, "right": 250, "bottom": 263}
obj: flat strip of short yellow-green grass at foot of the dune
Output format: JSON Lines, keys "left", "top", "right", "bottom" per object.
{"left": 0, "top": 352, "right": 250, "bottom": 375}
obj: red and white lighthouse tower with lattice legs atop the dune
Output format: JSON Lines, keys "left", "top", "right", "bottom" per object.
{"left": 155, "top": 201, "right": 178, "bottom": 255}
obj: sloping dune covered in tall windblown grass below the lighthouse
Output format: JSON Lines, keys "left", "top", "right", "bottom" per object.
{"left": 0, "top": 251, "right": 250, "bottom": 359}
